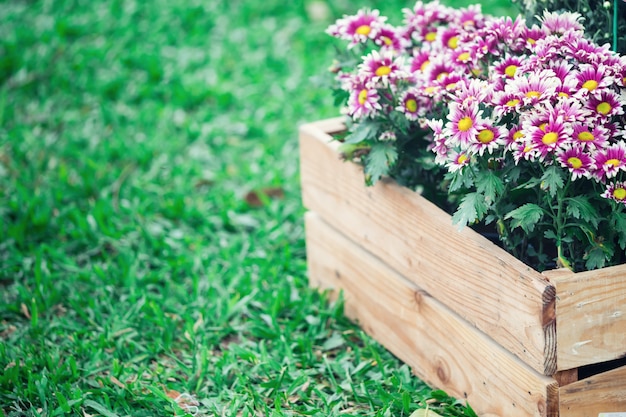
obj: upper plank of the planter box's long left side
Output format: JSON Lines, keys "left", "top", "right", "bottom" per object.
{"left": 300, "top": 119, "right": 556, "bottom": 375}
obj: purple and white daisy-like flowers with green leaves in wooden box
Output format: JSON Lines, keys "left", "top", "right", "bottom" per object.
{"left": 328, "top": 2, "right": 626, "bottom": 269}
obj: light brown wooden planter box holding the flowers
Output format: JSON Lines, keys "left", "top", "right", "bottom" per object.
{"left": 300, "top": 119, "right": 626, "bottom": 417}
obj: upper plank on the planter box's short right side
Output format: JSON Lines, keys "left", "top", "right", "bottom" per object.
{"left": 550, "top": 265, "right": 626, "bottom": 369}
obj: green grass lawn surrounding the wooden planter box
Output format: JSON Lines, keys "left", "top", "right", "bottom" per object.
{"left": 0, "top": 0, "right": 512, "bottom": 417}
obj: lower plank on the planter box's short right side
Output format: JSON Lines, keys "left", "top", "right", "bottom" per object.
{"left": 559, "top": 366, "right": 626, "bottom": 417}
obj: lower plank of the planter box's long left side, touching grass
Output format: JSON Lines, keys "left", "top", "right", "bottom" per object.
{"left": 305, "top": 212, "right": 558, "bottom": 417}
